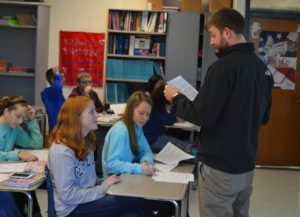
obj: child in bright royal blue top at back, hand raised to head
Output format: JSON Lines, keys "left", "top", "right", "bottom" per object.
{"left": 41, "top": 66, "right": 65, "bottom": 132}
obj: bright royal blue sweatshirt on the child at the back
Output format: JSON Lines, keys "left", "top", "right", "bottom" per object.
{"left": 41, "top": 73, "right": 65, "bottom": 131}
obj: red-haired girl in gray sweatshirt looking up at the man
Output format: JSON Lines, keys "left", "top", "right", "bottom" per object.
{"left": 47, "top": 96, "right": 149, "bottom": 217}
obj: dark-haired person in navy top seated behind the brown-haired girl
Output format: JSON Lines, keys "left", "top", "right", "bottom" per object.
{"left": 143, "top": 75, "right": 192, "bottom": 152}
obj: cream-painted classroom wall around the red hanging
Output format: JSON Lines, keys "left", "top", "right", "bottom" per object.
{"left": 45, "top": 0, "right": 147, "bottom": 100}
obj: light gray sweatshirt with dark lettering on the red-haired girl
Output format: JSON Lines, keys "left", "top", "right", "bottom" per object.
{"left": 47, "top": 144, "right": 109, "bottom": 217}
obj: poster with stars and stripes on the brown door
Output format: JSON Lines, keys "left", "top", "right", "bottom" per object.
{"left": 258, "top": 31, "right": 298, "bottom": 90}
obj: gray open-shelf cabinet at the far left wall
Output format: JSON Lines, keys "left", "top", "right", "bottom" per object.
{"left": 0, "top": 1, "right": 50, "bottom": 105}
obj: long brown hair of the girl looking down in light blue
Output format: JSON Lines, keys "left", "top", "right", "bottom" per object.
{"left": 123, "top": 91, "right": 153, "bottom": 156}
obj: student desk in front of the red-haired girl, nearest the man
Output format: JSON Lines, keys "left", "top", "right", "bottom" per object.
{"left": 107, "top": 164, "right": 195, "bottom": 217}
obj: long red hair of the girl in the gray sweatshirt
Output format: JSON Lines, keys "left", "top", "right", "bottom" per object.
{"left": 49, "top": 96, "right": 96, "bottom": 160}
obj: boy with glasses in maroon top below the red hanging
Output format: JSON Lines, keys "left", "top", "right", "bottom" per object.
{"left": 69, "top": 72, "right": 104, "bottom": 113}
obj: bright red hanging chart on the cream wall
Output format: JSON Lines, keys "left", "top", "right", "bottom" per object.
{"left": 59, "top": 31, "right": 105, "bottom": 87}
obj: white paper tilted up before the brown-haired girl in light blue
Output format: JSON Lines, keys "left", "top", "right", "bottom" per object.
{"left": 154, "top": 142, "right": 194, "bottom": 166}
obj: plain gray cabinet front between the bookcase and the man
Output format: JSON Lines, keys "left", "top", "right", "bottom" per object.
{"left": 166, "top": 12, "right": 200, "bottom": 87}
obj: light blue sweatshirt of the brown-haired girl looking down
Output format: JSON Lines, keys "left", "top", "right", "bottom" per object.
{"left": 102, "top": 121, "right": 154, "bottom": 177}
